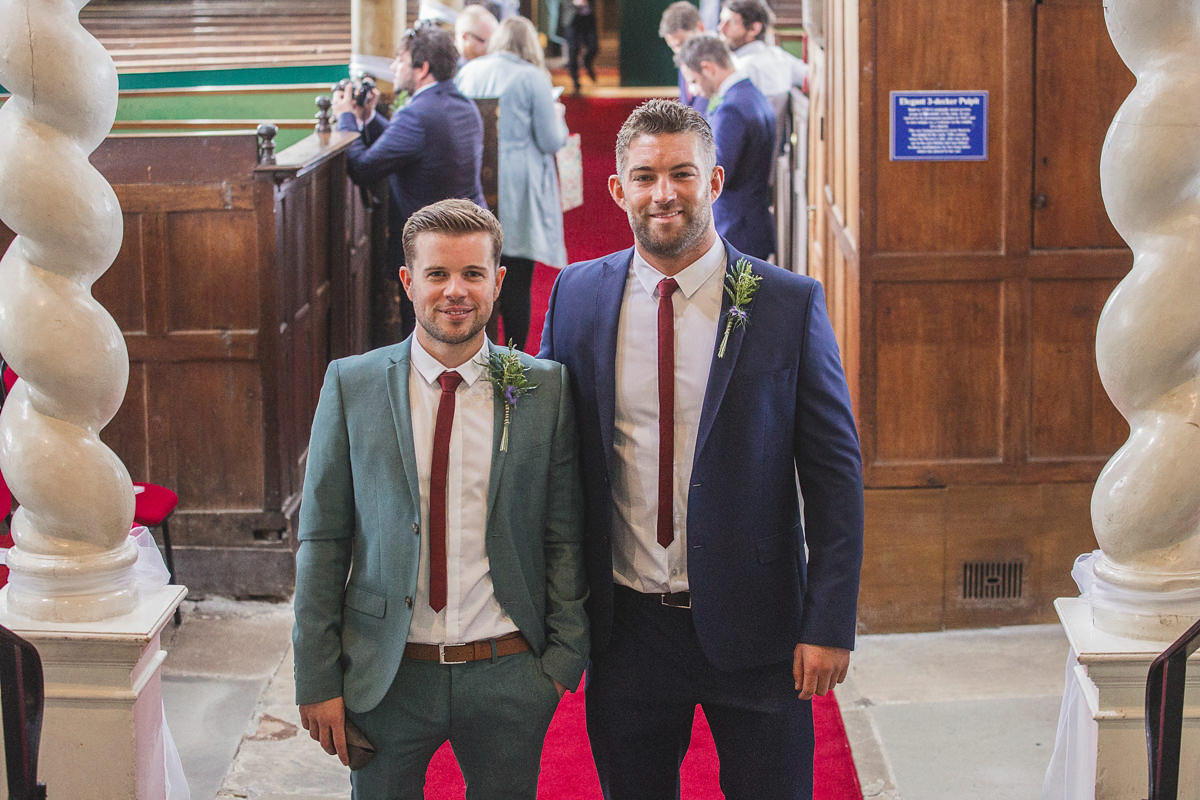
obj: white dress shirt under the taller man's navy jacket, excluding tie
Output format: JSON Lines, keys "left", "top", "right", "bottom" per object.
{"left": 612, "top": 239, "right": 725, "bottom": 593}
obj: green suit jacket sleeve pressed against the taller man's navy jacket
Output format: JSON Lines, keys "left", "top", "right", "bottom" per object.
{"left": 541, "top": 366, "right": 588, "bottom": 690}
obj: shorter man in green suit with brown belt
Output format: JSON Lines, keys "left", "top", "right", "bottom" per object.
{"left": 293, "top": 200, "right": 588, "bottom": 800}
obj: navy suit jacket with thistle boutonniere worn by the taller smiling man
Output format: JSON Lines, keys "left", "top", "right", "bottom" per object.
{"left": 540, "top": 242, "right": 863, "bottom": 669}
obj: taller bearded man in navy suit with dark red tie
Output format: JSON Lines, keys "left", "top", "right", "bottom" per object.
{"left": 541, "top": 100, "right": 863, "bottom": 800}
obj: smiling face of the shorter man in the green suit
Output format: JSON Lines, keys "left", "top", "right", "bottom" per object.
{"left": 400, "top": 231, "right": 504, "bottom": 367}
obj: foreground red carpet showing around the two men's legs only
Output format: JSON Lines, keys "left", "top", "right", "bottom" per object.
{"left": 425, "top": 692, "right": 863, "bottom": 800}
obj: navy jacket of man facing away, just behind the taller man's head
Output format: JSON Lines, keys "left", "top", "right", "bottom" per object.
{"left": 708, "top": 79, "right": 775, "bottom": 258}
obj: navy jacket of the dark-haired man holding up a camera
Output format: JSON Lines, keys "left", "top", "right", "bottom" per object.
{"left": 338, "top": 80, "right": 487, "bottom": 267}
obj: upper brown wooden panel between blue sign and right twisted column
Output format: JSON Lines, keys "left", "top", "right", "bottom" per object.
{"left": 1032, "top": 0, "right": 1135, "bottom": 248}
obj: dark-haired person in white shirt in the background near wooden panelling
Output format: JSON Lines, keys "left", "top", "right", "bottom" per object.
{"left": 716, "top": 0, "right": 809, "bottom": 97}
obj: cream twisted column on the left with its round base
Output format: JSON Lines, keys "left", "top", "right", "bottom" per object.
{"left": 0, "top": 0, "right": 137, "bottom": 621}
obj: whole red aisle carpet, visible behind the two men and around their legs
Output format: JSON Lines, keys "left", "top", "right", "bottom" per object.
{"left": 472, "top": 96, "right": 863, "bottom": 800}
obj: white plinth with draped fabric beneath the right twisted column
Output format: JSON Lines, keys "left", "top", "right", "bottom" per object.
{"left": 1055, "top": 597, "right": 1200, "bottom": 800}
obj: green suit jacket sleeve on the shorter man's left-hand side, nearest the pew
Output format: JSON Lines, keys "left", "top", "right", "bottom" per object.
{"left": 292, "top": 362, "right": 354, "bottom": 704}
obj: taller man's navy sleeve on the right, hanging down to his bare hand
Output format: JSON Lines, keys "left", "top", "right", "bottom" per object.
{"left": 794, "top": 284, "right": 863, "bottom": 649}
